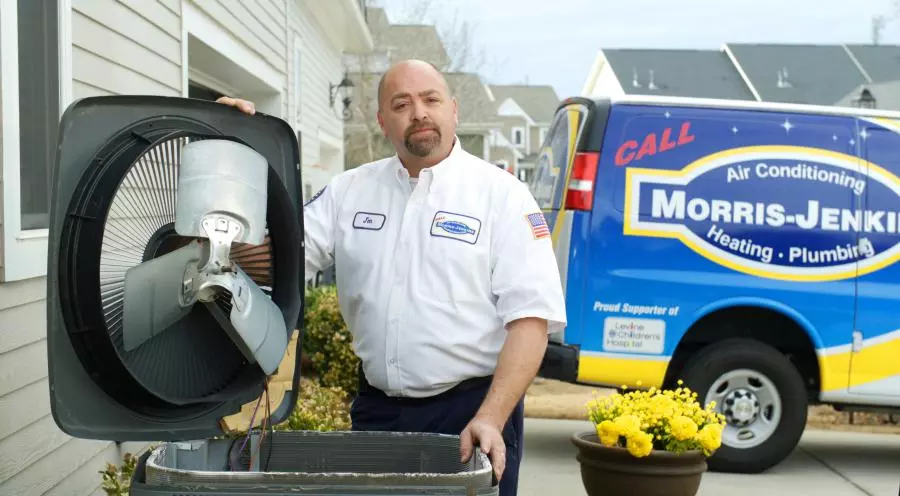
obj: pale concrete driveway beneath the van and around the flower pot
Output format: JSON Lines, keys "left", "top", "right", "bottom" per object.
{"left": 519, "top": 419, "right": 900, "bottom": 496}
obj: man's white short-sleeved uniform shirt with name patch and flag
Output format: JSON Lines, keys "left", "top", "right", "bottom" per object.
{"left": 304, "top": 139, "right": 566, "bottom": 397}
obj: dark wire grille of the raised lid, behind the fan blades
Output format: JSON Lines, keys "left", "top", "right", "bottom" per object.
{"left": 100, "top": 137, "right": 273, "bottom": 401}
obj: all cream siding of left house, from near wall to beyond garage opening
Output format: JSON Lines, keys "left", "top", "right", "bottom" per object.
{"left": 0, "top": 0, "right": 366, "bottom": 496}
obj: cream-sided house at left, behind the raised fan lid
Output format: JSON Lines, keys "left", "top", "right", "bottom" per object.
{"left": 0, "top": 0, "right": 372, "bottom": 495}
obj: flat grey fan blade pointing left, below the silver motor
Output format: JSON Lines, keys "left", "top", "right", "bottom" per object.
{"left": 122, "top": 241, "right": 204, "bottom": 351}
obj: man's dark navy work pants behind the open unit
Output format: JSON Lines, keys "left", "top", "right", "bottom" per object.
{"left": 350, "top": 379, "right": 524, "bottom": 496}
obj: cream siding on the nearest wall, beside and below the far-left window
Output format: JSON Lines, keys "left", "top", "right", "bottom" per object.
{"left": 0, "top": 0, "right": 181, "bottom": 495}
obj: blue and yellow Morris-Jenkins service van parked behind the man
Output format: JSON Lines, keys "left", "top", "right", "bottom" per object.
{"left": 530, "top": 96, "right": 900, "bottom": 472}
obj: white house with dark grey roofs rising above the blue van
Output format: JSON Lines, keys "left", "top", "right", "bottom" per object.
{"left": 582, "top": 43, "right": 900, "bottom": 110}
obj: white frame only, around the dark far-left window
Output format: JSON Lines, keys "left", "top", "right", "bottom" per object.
{"left": 0, "top": 0, "right": 72, "bottom": 282}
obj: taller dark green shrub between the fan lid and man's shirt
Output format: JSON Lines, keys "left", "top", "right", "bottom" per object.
{"left": 303, "top": 286, "right": 359, "bottom": 396}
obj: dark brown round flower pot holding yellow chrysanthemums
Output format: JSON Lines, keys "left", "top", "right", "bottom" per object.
{"left": 572, "top": 431, "right": 706, "bottom": 496}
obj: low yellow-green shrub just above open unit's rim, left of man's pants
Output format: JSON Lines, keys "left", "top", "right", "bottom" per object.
{"left": 275, "top": 379, "right": 350, "bottom": 431}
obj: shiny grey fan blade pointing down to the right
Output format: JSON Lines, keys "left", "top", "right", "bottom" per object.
{"left": 231, "top": 265, "right": 288, "bottom": 375}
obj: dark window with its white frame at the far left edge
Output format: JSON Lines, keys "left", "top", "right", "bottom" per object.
{"left": 0, "top": 0, "right": 72, "bottom": 281}
